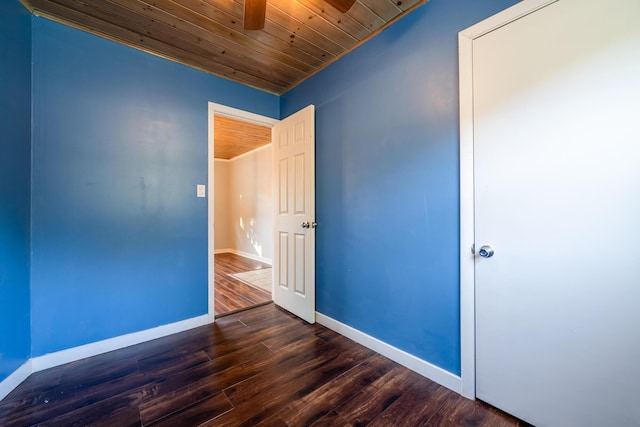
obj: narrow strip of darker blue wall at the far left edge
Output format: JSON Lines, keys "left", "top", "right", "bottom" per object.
{"left": 0, "top": 1, "right": 31, "bottom": 381}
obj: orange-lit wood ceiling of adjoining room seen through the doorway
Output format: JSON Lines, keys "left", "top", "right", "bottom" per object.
{"left": 213, "top": 115, "right": 271, "bottom": 160}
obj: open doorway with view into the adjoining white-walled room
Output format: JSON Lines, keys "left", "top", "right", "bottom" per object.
{"left": 208, "top": 103, "right": 277, "bottom": 321}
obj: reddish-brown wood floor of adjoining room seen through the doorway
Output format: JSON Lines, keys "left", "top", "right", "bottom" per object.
{"left": 214, "top": 253, "right": 271, "bottom": 316}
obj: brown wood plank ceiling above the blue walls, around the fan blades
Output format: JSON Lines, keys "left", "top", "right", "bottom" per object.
{"left": 22, "top": 0, "right": 427, "bottom": 94}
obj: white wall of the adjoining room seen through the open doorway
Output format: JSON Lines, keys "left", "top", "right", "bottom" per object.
{"left": 215, "top": 145, "right": 273, "bottom": 260}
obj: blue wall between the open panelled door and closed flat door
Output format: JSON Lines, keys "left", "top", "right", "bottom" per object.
{"left": 281, "top": 0, "right": 516, "bottom": 375}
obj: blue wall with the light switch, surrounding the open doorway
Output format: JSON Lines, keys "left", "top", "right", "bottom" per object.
{"left": 31, "top": 18, "right": 279, "bottom": 356}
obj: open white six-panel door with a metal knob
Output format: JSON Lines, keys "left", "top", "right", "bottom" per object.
{"left": 272, "top": 105, "right": 316, "bottom": 323}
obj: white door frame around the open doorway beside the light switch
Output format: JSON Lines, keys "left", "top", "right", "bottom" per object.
{"left": 207, "top": 102, "right": 280, "bottom": 323}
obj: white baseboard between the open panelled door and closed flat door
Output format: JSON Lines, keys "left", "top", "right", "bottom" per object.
{"left": 316, "top": 312, "right": 462, "bottom": 393}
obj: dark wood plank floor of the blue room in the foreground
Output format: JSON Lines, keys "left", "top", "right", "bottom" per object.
{"left": 0, "top": 304, "right": 526, "bottom": 427}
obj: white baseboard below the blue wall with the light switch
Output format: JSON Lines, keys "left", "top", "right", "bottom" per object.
{"left": 30, "top": 314, "right": 209, "bottom": 372}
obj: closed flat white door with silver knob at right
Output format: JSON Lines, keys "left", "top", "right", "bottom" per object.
{"left": 473, "top": 0, "right": 640, "bottom": 427}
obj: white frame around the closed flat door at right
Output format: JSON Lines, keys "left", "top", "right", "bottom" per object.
{"left": 458, "top": 0, "right": 558, "bottom": 399}
